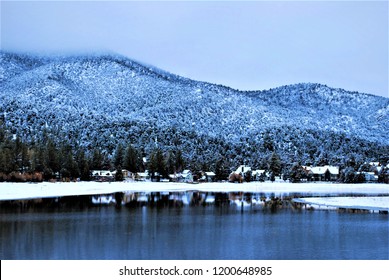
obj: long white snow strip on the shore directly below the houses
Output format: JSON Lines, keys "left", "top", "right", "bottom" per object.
{"left": 0, "top": 181, "right": 389, "bottom": 200}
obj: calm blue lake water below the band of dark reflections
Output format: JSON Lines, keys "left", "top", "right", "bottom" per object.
{"left": 0, "top": 206, "right": 389, "bottom": 260}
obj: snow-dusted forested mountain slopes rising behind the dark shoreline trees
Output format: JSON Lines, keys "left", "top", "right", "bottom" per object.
{"left": 0, "top": 52, "right": 389, "bottom": 167}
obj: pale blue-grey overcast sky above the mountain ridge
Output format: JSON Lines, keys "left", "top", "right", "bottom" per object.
{"left": 1, "top": 1, "right": 389, "bottom": 97}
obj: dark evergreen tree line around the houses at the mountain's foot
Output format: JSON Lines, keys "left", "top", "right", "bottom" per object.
{"left": 0, "top": 124, "right": 387, "bottom": 183}
